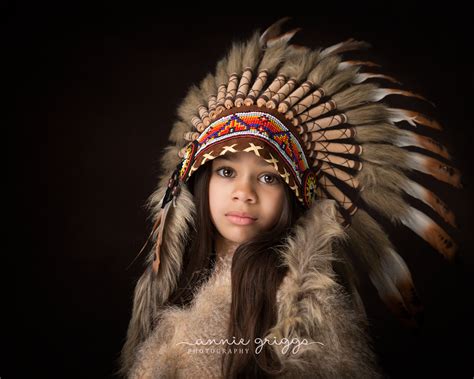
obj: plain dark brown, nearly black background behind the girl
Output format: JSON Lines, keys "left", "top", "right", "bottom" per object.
{"left": 10, "top": 4, "right": 474, "bottom": 378}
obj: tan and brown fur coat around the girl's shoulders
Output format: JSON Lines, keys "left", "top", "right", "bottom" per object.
{"left": 123, "top": 188, "right": 381, "bottom": 379}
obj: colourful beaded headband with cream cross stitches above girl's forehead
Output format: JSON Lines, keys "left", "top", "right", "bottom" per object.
{"left": 179, "top": 106, "right": 316, "bottom": 207}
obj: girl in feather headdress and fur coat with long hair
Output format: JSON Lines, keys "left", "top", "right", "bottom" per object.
{"left": 122, "top": 22, "right": 459, "bottom": 378}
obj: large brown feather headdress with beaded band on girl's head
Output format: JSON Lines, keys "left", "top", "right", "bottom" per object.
{"left": 148, "top": 22, "right": 460, "bottom": 332}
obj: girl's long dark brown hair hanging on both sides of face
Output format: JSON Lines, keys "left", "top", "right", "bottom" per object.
{"left": 168, "top": 160, "right": 303, "bottom": 378}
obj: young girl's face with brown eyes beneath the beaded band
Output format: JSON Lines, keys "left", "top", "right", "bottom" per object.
{"left": 209, "top": 152, "right": 285, "bottom": 248}
